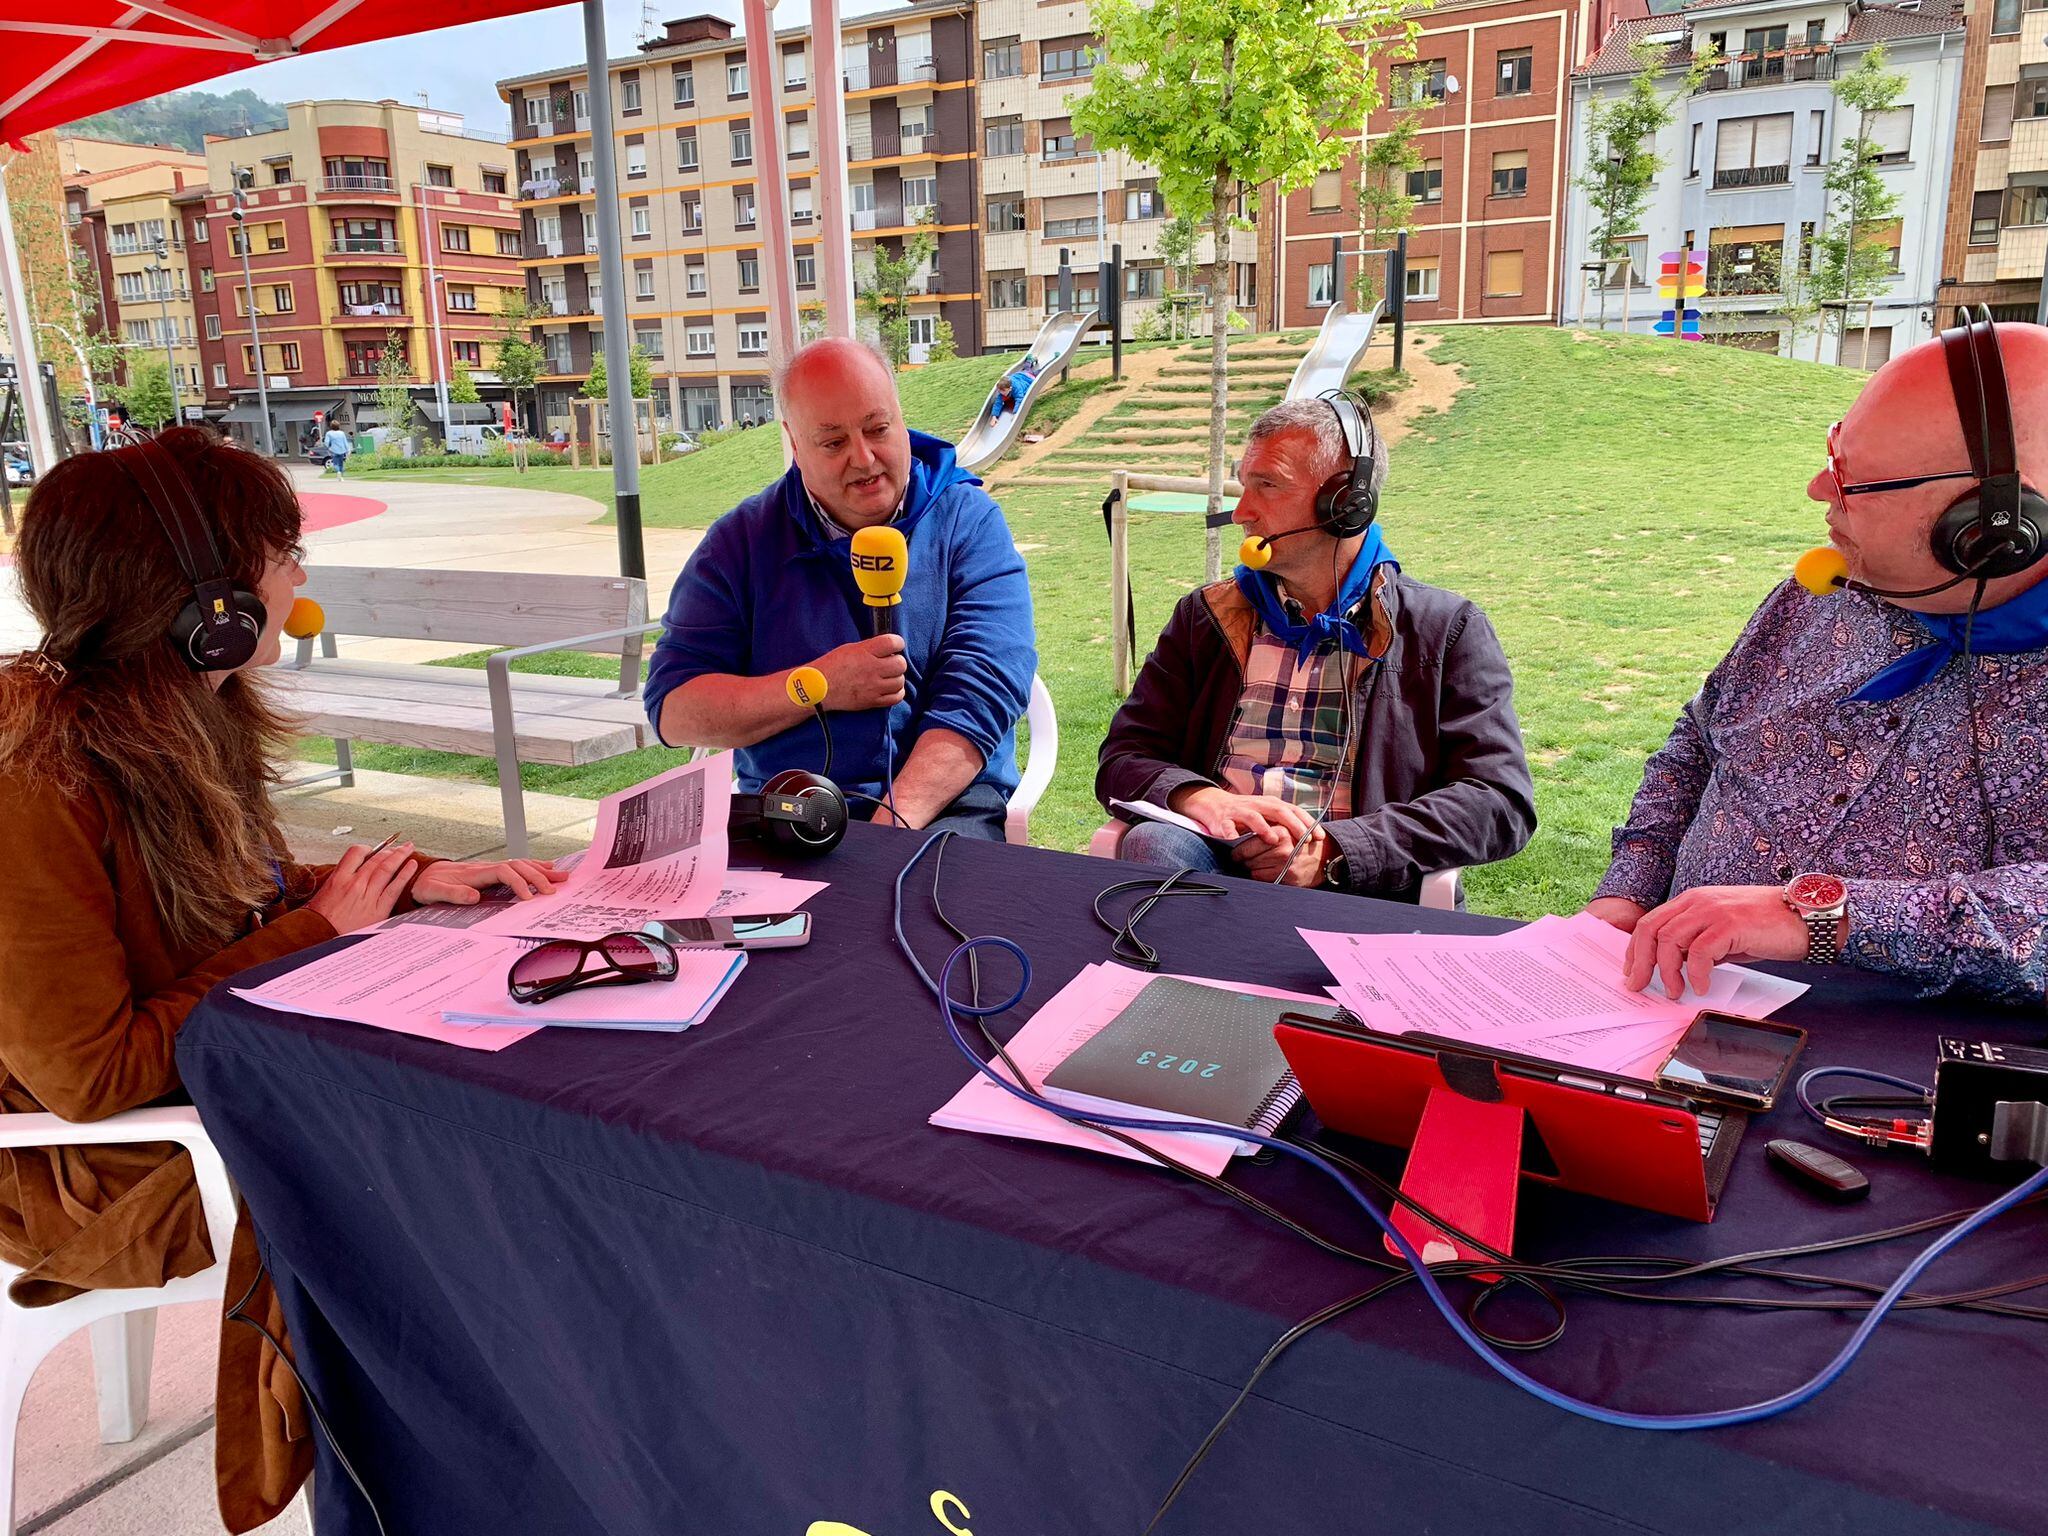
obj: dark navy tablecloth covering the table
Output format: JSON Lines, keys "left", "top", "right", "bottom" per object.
{"left": 178, "top": 825, "right": 2048, "bottom": 1536}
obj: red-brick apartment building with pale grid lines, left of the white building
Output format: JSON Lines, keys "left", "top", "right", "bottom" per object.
{"left": 1262, "top": 0, "right": 1604, "bottom": 326}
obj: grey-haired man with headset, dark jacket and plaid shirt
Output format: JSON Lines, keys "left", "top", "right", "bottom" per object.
{"left": 1096, "top": 399, "right": 1536, "bottom": 901}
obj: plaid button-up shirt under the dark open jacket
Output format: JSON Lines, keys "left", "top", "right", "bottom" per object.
{"left": 1221, "top": 596, "right": 1370, "bottom": 821}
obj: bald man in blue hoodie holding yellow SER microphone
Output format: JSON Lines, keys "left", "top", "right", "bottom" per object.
{"left": 645, "top": 338, "right": 1038, "bottom": 842}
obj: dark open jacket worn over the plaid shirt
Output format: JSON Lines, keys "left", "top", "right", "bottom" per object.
{"left": 1096, "top": 567, "right": 1536, "bottom": 901}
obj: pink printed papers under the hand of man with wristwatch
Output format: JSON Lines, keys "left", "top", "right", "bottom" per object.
{"left": 1298, "top": 911, "right": 1806, "bottom": 1079}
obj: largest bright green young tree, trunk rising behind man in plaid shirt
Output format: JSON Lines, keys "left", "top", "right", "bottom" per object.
{"left": 1073, "top": 0, "right": 1403, "bottom": 578}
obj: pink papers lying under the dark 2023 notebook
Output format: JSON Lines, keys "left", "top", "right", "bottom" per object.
{"left": 932, "top": 963, "right": 1327, "bottom": 1176}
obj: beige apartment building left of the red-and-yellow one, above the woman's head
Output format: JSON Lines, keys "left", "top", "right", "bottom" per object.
{"left": 55, "top": 135, "right": 207, "bottom": 397}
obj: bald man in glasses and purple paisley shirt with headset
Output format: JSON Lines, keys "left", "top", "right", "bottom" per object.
{"left": 1587, "top": 326, "right": 2048, "bottom": 1004}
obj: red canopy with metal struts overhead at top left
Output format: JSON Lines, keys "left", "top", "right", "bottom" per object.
{"left": 0, "top": 0, "right": 561, "bottom": 143}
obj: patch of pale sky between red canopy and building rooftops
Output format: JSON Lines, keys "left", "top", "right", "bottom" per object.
{"left": 199, "top": 0, "right": 891, "bottom": 135}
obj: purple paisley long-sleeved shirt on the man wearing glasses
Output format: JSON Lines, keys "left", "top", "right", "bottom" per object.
{"left": 1595, "top": 582, "right": 2048, "bottom": 1004}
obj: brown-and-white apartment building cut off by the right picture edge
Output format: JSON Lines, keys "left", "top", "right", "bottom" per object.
{"left": 1937, "top": 0, "right": 2048, "bottom": 324}
